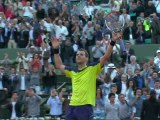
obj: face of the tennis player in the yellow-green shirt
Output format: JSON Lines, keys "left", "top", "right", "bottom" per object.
{"left": 76, "top": 51, "right": 88, "bottom": 64}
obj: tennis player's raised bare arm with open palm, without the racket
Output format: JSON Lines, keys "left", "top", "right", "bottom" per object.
{"left": 51, "top": 38, "right": 65, "bottom": 73}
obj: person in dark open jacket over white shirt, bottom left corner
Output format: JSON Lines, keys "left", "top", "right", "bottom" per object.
{"left": 7, "top": 91, "right": 22, "bottom": 119}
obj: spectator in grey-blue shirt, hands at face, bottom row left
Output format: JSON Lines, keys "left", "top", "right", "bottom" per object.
{"left": 25, "top": 88, "right": 42, "bottom": 117}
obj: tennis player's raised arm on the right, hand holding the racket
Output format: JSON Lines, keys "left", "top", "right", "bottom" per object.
{"left": 100, "top": 33, "right": 122, "bottom": 66}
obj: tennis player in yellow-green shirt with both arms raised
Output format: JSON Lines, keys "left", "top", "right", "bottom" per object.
{"left": 51, "top": 33, "right": 121, "bottom": 120}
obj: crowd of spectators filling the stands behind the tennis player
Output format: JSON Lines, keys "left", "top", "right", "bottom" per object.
{"left": 0, "top": 0, "right": 160, "bottom": 120}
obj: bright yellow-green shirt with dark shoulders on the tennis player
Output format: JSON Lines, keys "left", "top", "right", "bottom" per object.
{"left": 65, "top": 62, "right": 102, "bottom": 106}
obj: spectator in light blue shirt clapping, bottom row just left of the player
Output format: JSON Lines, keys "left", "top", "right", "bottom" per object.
{"left": 47, "top": 89, "right": 64, "bottom": 119}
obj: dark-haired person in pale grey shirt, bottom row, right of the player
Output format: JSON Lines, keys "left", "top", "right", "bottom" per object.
{"left": 105, "top": 93, "right": 120, "bottom": 120}
